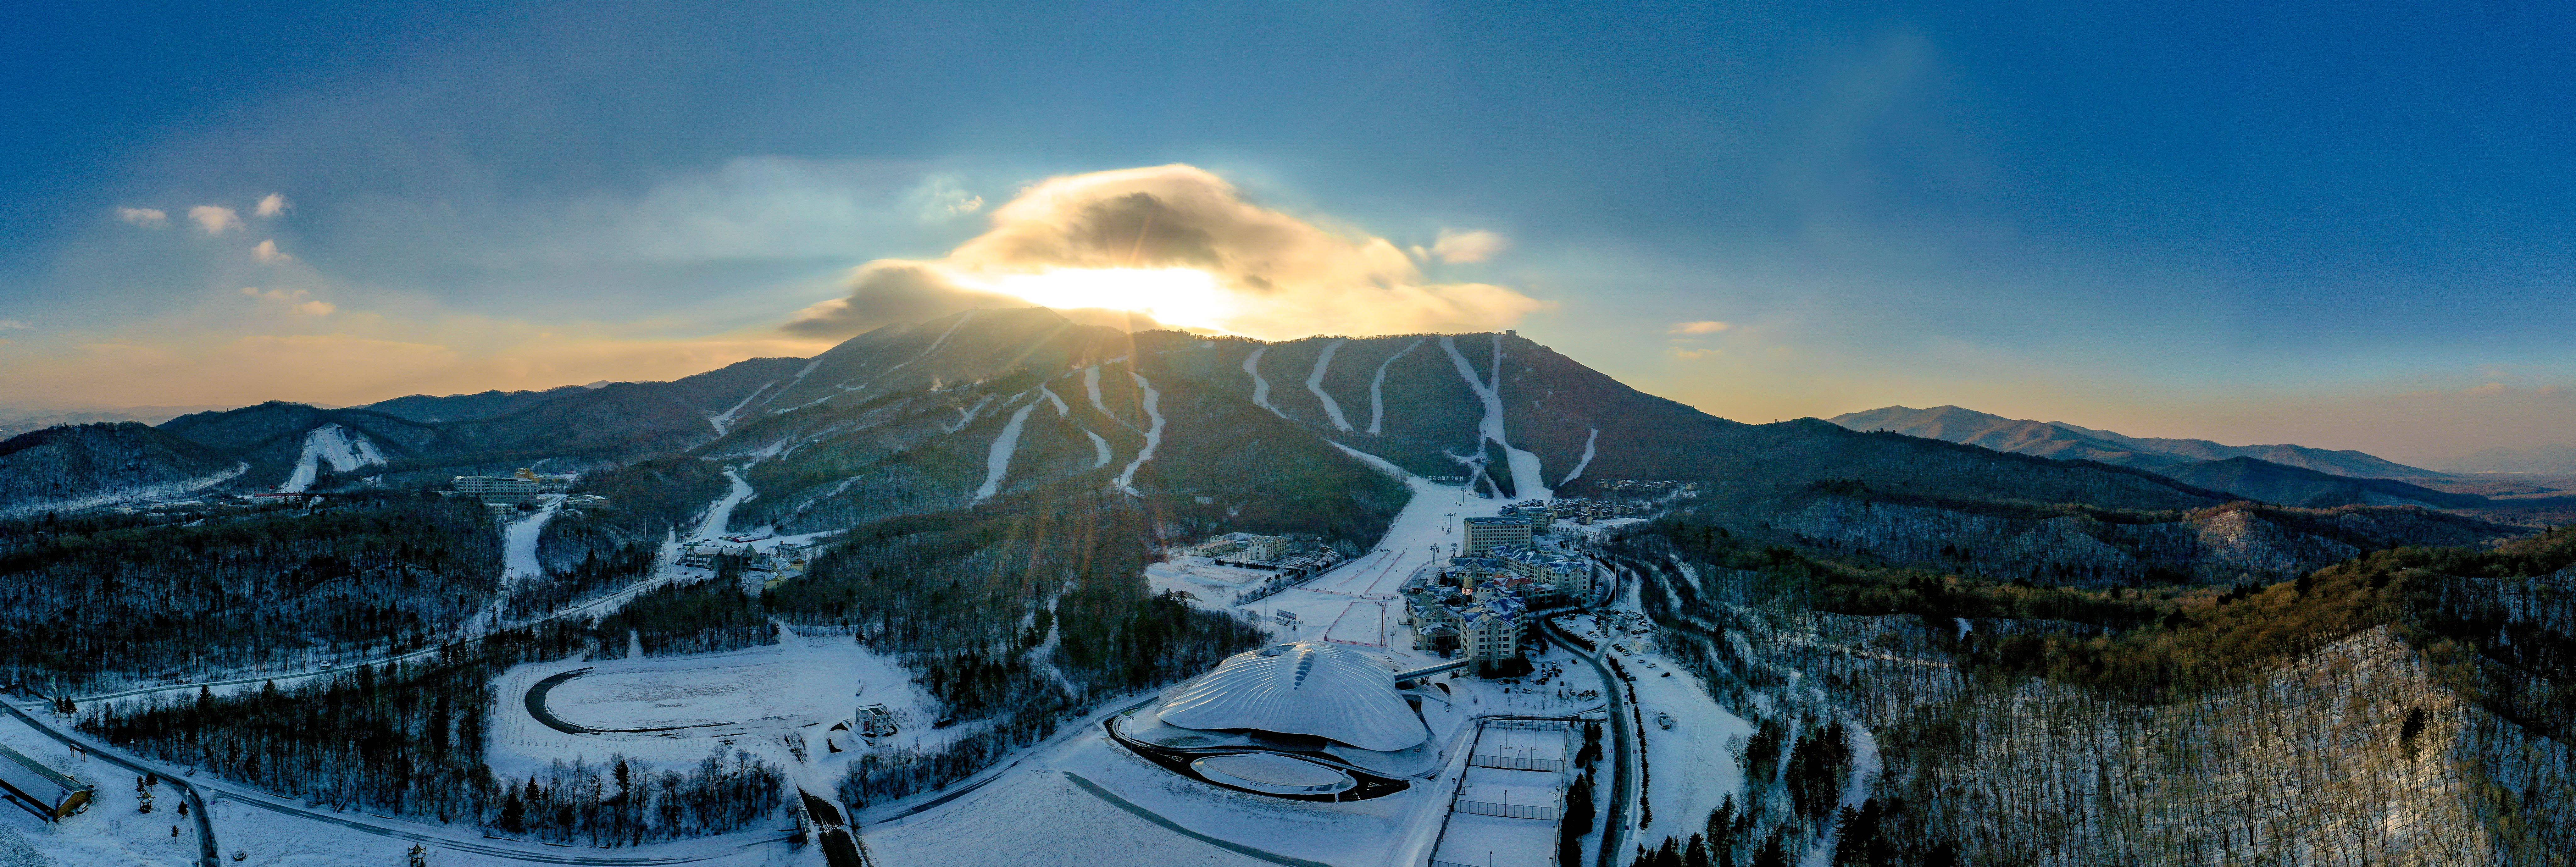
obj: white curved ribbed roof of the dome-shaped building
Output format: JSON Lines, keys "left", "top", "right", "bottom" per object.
{"left": 1157, "top": 641, "right": 1430, "bottom": 751}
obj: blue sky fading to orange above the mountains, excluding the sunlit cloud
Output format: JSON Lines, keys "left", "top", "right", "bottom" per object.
{"left": 0, "top": 0, "right": 2576, "bottom": 461}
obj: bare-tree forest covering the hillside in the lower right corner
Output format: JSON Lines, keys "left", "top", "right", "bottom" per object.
{"left": 1613, "top": 509, "right": 2576, "bottom": 864}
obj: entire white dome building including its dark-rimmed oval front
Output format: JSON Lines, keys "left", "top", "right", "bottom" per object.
{"left": 1110, "top": 641, "right": 1437, "bottom": 800}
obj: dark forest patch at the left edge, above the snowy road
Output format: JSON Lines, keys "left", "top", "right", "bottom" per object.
{"left": 0, "top": 494, "right": 500, "bottom": 692}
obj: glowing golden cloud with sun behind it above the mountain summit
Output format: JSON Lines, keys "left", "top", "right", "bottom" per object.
{"left": 786, "top": 165, "right": 1546, "bottom": 340}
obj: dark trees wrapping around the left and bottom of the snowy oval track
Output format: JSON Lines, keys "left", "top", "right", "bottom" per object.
{"left": 77, "top": 623, "right": 783, "bottom": 847}
